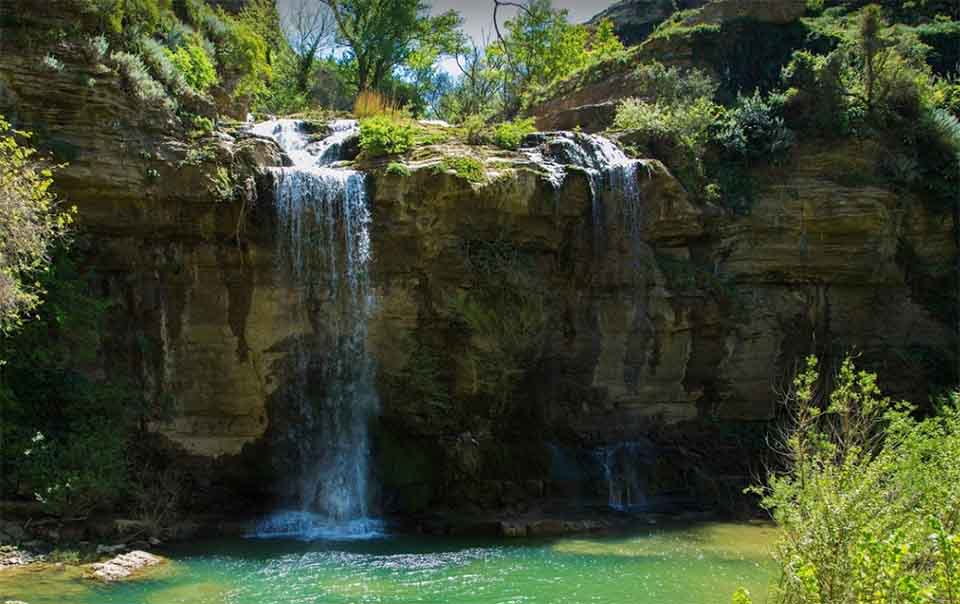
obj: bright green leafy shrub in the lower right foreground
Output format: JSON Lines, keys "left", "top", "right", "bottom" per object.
{"left": 756, "top": 358, "right": 960, "bottom": 604}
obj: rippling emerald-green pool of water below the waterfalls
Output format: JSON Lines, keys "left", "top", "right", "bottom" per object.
{"left": 0, "top": 524, "right": 775, "bottom": 604}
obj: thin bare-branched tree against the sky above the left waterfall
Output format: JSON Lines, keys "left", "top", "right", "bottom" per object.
{"left": 282, "top": 0, "right": 337, "bottom": 93}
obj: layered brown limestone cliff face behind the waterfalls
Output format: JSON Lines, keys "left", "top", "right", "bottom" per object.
{"left": 0, "top": 0, "right": 955, "bottom": 512}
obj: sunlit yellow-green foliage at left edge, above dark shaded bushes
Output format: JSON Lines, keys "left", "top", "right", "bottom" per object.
{"left": 0, "top": 117, "right": 72, "bottom": 336}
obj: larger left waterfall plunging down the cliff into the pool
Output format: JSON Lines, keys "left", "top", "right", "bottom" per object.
{"left": 250, "top": 119, "right": 383, "bottom": 539}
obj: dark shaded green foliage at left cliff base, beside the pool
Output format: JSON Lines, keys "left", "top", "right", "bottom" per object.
{"left": 0, "top": 250, "right": 145, "bottom": 516}
